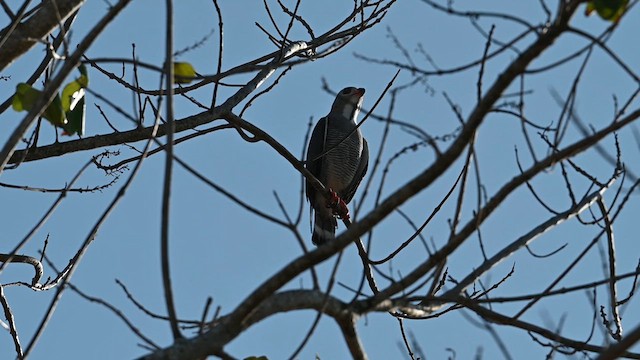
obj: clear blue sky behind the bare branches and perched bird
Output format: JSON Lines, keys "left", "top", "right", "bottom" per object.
{"left": 0, "top": 0, "right": 640, "bottom": 359}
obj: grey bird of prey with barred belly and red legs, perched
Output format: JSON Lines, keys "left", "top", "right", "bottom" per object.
{"left": 305, "top": 87, "right": 369, "bottom": 246}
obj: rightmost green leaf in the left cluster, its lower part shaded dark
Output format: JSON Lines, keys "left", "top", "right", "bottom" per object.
{"left": 62, "top": 64, "right": 89, "bottom": 136}
